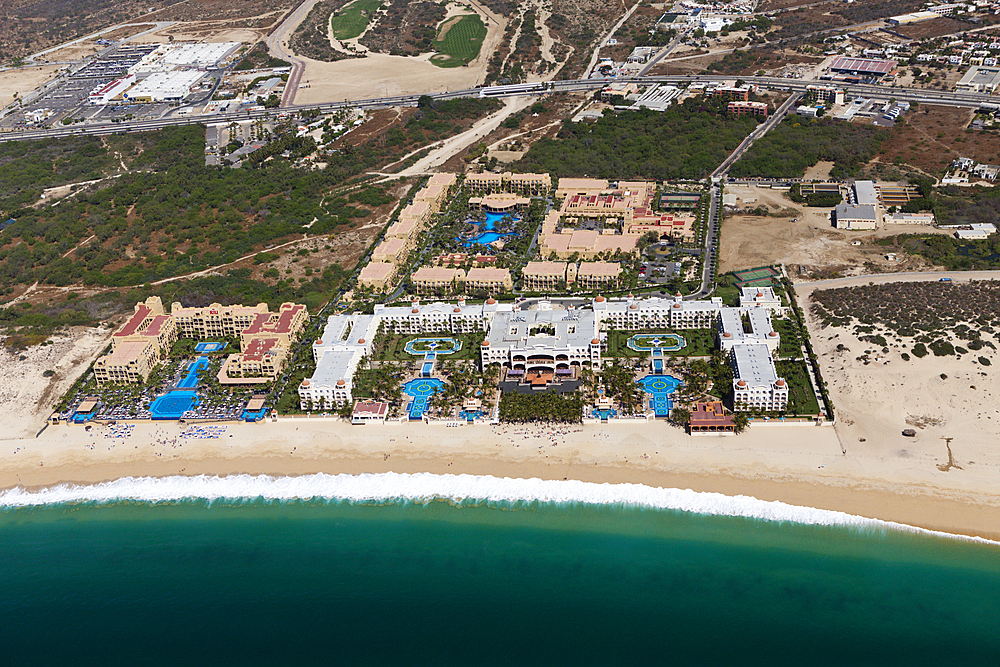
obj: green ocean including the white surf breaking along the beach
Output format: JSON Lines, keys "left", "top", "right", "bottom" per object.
{"left": 0, "top": 474, "right": 1000, "bottom": 666}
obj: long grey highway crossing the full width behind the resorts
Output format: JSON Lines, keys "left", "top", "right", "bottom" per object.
{"left": 0, "top": 74, "right": 1000, "bottom": 142}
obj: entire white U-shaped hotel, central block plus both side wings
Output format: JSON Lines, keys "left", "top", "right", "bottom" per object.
{"left": 299, "top": 288, "right": 788, "bottom": 411}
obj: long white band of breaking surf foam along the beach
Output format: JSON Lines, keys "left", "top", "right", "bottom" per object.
{"left": 0, "top": 472, "right": 1000, "bottom": 544}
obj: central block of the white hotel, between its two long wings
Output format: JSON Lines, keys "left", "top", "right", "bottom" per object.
{"left": 480, "top": 308, "right": 601, "bottom": 377}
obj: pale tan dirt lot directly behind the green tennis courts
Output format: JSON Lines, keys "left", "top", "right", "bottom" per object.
{"left": 719, "top": 186, "right": 945, "bottom": 278}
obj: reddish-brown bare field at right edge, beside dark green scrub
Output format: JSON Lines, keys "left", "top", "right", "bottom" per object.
{"left": 877, "top": 104, "right": 1000, "bottom": 177}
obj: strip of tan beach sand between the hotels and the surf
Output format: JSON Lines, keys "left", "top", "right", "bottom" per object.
{"left": 0, "top": 420, "right": 1000, "bottom": 540}
